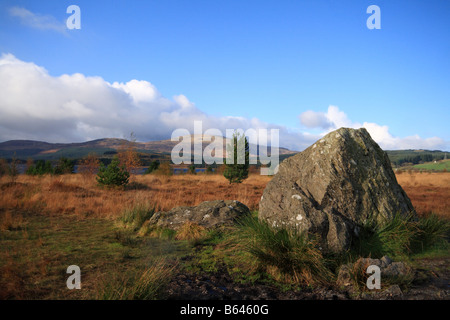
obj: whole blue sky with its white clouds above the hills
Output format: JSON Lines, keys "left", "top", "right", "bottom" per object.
{"left": 0, "top": 0, "right": 450, "bottom": 151}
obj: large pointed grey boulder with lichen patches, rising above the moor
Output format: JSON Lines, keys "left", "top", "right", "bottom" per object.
{"left": 259, "top": 128, "right": 415, "bottom": 252}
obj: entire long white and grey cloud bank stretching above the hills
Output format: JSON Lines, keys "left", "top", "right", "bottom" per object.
{"left": 0, "top": 54, "right": 444, "bottom": 151}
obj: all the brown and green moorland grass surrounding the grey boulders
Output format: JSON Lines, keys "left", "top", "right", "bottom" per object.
{"left": 0, "top": 174, "right": 450, "bottom": 299}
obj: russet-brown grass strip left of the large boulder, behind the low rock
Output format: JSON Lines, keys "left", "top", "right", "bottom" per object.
{"left": 0, "top": 174, "right": 270, "bottom": 219}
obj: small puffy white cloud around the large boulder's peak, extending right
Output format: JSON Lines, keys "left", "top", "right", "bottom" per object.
{"left": 299, "top": 105, "right": 446, "bottom": 150}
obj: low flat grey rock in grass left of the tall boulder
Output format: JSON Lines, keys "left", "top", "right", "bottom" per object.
{"left": 149, "top": 200, "right": 250, "bottom": 230}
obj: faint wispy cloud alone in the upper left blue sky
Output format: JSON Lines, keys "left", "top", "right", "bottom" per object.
{"left": 8, "top": 7, "right": 66, "bottom": 33}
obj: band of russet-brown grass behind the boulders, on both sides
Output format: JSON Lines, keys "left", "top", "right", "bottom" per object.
{"left": 0, "top": 172, "right": 450, "bottom": 220}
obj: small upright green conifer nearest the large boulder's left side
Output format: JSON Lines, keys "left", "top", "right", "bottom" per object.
{"left": 223, "top": 132, "right": 250, "bottom": 184}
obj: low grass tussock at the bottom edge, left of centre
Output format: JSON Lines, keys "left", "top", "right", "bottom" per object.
{"left": 97, "top": 260, "right": 175, "bottom": 300}
